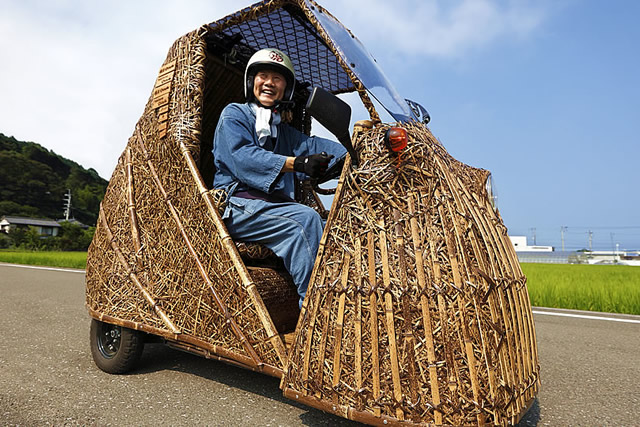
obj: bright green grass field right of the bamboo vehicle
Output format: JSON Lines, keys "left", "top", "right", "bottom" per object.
{"left": 521, "top": 263, "right": 640, "bottom": 315}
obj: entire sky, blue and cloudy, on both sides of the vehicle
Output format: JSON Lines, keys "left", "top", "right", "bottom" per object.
{"left": 0, "top": 0, "right": 640, "bottom": 250}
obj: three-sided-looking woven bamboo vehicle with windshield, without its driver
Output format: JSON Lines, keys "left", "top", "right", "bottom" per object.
{"left": 86, "top": 0, "right": 540, "bottom": 425}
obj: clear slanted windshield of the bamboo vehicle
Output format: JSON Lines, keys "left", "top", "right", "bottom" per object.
{"left": 305, "top": 0, "right": 415, "bottom": 122}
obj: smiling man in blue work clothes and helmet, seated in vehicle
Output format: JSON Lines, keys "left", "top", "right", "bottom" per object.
{"left": 213, "top": 49, "right": 346, "bottom": 305}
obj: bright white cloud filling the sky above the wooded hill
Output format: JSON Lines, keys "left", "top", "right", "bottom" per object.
{"left": 0, "top": 0, "right": 246, "bottom": 178}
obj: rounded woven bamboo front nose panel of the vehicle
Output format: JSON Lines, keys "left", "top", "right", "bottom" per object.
{"left": 282, "top": 124, "right": 539, "bottom": 425}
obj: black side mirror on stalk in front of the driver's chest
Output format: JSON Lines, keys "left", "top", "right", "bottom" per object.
{"left": 305, "top": 87, "right": 360, "bottom": 166}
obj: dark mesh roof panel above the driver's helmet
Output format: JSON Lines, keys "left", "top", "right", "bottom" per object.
{"left": 211, "top": 5, "right": 355, "bottom": 93}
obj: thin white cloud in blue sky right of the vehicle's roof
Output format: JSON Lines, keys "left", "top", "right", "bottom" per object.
{"left": 330, "top": 0, "right": 547, "bottom": 58}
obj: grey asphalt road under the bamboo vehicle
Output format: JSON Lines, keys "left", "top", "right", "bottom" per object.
{"left": 0, "top": 264, "right": 640, "bottom": 426}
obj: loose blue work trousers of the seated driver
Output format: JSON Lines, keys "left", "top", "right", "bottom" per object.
{"left": 224, "top": 197, "right": 324, "bottom": 307}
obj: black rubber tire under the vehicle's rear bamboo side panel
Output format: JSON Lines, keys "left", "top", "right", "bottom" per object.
{"left": 89, "top": 319, "right": 144, "bottom": 374}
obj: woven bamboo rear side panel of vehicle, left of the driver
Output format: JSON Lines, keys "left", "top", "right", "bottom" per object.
{"left": 86, "top": 30, "right": 286, "bottom": 375}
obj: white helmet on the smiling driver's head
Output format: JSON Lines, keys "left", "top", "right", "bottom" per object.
{"left": 244, "top": 48, "right": 296, "bottom": 108}
